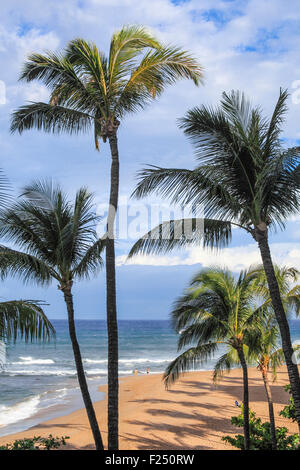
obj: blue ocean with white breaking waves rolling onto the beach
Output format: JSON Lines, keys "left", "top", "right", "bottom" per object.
{"left": 0, "top": 320, "right": 300, "bottom": 436}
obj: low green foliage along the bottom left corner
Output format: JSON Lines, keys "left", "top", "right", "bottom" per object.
{"left": 0, "top": 434, "right": 70, "bottom": 450}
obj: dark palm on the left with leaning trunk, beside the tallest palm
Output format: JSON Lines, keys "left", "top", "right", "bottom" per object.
{"left": 0, "top": 182, "right": 104, "bottom": 450}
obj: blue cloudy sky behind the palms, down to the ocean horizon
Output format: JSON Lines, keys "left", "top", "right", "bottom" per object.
{"left": 0, "top": 0, "right": 300, "bottom": 319}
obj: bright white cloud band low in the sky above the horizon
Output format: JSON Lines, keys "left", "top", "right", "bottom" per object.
{"left": 117, "top": 243, "right": 300, "bottom": 272}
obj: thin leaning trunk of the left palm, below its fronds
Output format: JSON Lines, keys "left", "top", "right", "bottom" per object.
{"left": 62, "top": 287, "right": 104, "bottom": 450}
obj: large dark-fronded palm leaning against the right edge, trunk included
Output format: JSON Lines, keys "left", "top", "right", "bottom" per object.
{"left": 130, "top": 90, "right": 300, "bottom": 429}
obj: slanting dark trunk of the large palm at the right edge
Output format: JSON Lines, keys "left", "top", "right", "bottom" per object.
{"left": 255, "top": 230, "right": 300, "bottom": 431}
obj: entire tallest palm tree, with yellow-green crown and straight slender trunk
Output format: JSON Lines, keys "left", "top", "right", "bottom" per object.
{"left": 11, "top": 26, "right": 202, "bottom": 449}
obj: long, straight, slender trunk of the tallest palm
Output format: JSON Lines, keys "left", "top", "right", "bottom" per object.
{"left": 105, "top": 132, "right": 119, "bottom": 450}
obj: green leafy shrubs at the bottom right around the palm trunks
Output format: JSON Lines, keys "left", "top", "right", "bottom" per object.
{"left": 222, "top": 410, "right": 300, "bottom": 450}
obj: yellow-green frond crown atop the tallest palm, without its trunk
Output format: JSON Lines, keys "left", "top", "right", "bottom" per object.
{"left": 11, "top": 26, "right": 202, "bottom": 148}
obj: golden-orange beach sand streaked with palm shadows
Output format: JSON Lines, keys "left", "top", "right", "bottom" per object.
{"left": 0, "top": 368, "right": 297, "bottom": 450}
